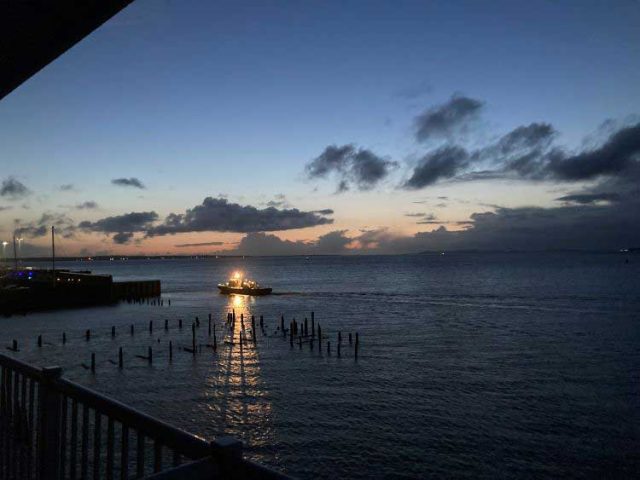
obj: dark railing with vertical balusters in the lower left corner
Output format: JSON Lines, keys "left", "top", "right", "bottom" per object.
{"left": 0, "top": 354, "right": 289, "bottom": 480}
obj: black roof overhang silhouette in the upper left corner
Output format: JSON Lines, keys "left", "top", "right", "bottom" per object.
{"left": 0, "top": 0, "right": 134, "bottom": 99}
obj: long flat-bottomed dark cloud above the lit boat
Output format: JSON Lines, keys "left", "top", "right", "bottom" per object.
{"left": 147, "top": 197, "right": 333, "bottom": 236}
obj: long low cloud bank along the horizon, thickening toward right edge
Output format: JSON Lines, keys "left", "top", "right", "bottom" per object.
{"left": 225, "top": 186, "right": 640, "bottom": 255}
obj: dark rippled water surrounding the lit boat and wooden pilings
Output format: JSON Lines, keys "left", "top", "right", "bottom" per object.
{"left": 0, "top": 254, "right": 640, "bottom": 478}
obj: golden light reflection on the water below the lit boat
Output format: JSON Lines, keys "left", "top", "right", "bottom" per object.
{"left": 205, "top": 295, "right": 274, "bottom": 447}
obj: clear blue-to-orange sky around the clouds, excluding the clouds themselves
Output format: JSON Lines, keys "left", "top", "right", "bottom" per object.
{"left": 0, "top": 0, "right": 640, "bottom": 252}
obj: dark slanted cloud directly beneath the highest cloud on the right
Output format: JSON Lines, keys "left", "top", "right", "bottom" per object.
{"left": 404, "top": 146, "right": 470, "bottom": 189}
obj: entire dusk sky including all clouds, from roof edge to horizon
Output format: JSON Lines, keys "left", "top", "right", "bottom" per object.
{"left": 0, "top": 0, "right": 640, "bottom": 255}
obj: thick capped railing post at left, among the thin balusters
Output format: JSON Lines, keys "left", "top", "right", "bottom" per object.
{"left": 38, "top": 367, "right": 62, "bottom": 480}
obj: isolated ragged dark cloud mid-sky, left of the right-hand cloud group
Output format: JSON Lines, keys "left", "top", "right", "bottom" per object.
{"left": 305, "top": 145, "right": 398, "bottom": 192}
